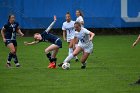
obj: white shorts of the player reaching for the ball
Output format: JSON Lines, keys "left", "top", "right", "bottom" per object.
{"left": 78, "top": 43, "right": 93, "bottom": 54}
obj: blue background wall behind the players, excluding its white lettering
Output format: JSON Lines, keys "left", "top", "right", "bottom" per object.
{"left": 0, "top": 0, "right": 140, "bottom": 29}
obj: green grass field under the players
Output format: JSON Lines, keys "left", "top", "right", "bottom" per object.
{"left": 0, "top": 35, "right": 140, "bottom": 93}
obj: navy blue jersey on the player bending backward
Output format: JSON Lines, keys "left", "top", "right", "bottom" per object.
{"left": 40, "top": 31, "right": 59, "bottom": 44}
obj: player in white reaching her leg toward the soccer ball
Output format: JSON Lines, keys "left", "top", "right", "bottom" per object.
{"left": 61, "top": 22, "right": 95, "bottom": 69}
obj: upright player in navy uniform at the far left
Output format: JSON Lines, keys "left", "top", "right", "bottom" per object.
{"left": 1, "top": 15, "right": 24, "bottom": 67}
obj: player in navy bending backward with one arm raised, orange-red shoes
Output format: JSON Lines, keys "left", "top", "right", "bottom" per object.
{"left": 24, "top": 16, "right": 62, "bottom": 68}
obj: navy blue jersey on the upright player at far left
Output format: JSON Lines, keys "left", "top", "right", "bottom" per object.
{"left": 4, "top": 22, "right": 19, "bottom": 40}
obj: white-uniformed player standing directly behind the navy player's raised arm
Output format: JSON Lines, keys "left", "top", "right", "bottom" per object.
{"left": 62, "top": 12, "right": 78, "bottom": 62}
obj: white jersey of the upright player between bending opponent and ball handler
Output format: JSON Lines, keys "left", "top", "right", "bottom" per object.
{"left": 62, "top": 21, "right": 75, "bottom": 42}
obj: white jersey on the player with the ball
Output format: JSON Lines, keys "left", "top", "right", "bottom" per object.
{"left": 75, "top": 27, "right": 92, "bottom": 46}
